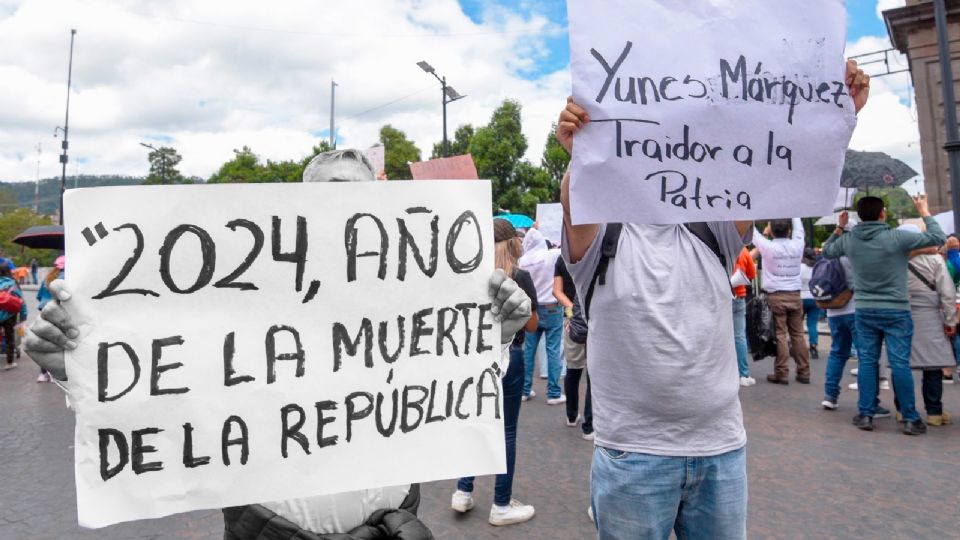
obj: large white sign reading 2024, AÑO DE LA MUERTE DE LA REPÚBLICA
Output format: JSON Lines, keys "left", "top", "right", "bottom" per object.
{"left": 65, "top": 181, "right": 506, "bottom": 527}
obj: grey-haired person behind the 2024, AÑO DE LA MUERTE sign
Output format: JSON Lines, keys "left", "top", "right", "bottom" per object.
{"left": 25, "top": 150, "right": 531, "bottom": 540}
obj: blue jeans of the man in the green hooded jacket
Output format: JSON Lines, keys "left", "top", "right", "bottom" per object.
{"left": 856, "top": 308, "right": 920, "bottom": 422}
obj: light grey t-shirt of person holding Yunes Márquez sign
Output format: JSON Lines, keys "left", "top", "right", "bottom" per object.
{"left": 563, "top": 222, "right": 752, "bottom": 457}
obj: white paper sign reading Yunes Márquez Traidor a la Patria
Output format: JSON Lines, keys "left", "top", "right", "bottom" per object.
{"left": 567, "top": 0, "right": 855, "bottom": 224}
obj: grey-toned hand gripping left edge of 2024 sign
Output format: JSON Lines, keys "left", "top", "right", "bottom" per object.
{"left": 23, "top": 279, "right": 80, "bottom": 381}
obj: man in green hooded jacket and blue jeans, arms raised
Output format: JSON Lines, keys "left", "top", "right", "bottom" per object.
{"left": 823, "top": 195, "right": 946, "bottom": 435}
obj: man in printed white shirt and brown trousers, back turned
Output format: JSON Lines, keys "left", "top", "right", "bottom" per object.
{"left": 753, "top": 218, "right": 810, "bottom": 384}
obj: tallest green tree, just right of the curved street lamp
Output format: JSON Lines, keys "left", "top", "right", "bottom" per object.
{"left": 470, "top": 99, "right": 527, "bottom": 209}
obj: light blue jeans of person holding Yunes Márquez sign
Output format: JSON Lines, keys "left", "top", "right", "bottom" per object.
{"left": 590, "top": 446, "right": 747, "bottom": 540}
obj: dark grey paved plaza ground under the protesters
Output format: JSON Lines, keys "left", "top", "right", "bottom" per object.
{"left": 0, "top": 295, "right": 960, "bottom": 540}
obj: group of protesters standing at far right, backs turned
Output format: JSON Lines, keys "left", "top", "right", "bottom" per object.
{"left": 748, "top": 195, "right": 960, "bottom": 435}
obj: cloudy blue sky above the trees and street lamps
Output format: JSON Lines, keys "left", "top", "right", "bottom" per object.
{"left": 0, "top": 0, "right": 920, "bottom": 190}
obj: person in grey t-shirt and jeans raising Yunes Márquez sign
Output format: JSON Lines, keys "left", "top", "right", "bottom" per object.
{"left": 557, "top": 57, "right": 869, "bottom": 539}
